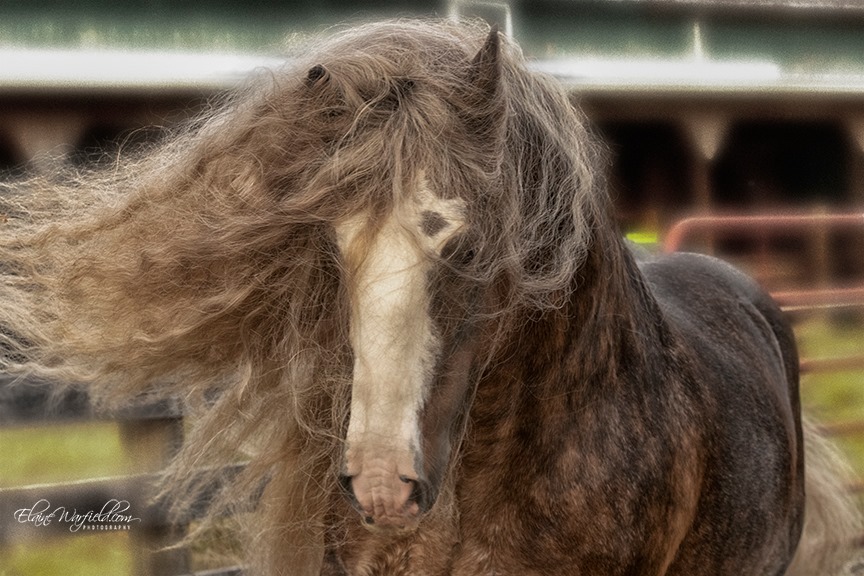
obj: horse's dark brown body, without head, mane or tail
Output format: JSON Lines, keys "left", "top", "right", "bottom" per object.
{"left": 324, "top": 235, "right": 804, "bottom": 575}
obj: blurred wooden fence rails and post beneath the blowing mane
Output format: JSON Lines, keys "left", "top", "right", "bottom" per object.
{"left": 0, "top": 375, "right": 241, "bottom": 576}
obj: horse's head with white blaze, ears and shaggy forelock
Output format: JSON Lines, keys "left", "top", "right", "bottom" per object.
{"left": 282, "top": 18, "right": 593, "bottom": 530}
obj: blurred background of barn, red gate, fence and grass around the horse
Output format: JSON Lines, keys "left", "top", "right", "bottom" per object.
{"left": 0, "top": 0, "right": 864, "bottom": 576}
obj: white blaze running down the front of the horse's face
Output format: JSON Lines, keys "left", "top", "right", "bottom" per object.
{"left": 336, "top": 178, "right": 464, "bottom": 512}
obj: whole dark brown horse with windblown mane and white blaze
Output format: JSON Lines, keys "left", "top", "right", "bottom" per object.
{"left": 0, "top": 20, "right": 860, "bottom": 576}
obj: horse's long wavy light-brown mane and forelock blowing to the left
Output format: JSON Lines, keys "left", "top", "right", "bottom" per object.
{"left": 0, "top": 21, "right": 606, "bottom": 574}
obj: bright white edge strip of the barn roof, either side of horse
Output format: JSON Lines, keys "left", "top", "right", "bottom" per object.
{"left": 0, "top": 47, "right": 864, "bottom": 95}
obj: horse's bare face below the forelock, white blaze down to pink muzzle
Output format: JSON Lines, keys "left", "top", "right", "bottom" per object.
{"left": 336, "top": 174, "right": 476, "bottom": 529}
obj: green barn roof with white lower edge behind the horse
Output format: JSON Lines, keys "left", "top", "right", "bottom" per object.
{"left": 0, "top": 0, "right": 864, "bottom": 96}
